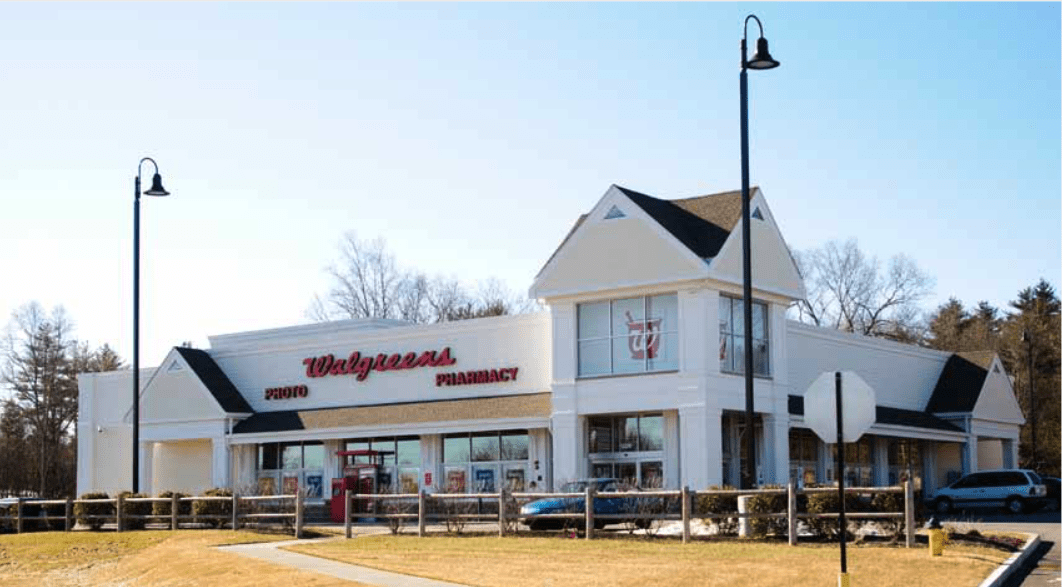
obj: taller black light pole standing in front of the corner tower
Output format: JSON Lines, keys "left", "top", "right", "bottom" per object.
{"left": 741, "top": 14, "right": 780, "bottom": 489}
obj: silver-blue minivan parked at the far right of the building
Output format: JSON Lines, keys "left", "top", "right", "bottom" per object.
{"left": 928, "top": 469, "right": 1047, "bottom": 514}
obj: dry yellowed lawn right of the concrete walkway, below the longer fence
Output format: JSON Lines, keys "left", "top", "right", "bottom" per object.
{"left": 288, "top": 535, "right": 1008, "bottom": 587}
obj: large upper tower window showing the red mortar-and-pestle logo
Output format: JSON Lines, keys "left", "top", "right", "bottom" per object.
{"left": 578, "top": 294, "right": 679, "bottom": 377}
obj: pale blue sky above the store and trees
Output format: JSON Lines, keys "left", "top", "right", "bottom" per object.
{"left": 0, "top": 2, "right": 1062, "bottom": 365}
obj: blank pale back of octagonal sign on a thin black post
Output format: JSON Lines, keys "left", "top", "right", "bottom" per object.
{"left": 804, "top": 370, "right": 877, "bottom": 444}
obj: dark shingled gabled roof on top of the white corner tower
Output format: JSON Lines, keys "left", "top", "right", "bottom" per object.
{"left": 616, "top": 186, "right": 757, "bottom": 259}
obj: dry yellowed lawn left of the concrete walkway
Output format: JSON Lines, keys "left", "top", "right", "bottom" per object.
{"left": 0, "top": 530, "right": 363, "bottom": 587}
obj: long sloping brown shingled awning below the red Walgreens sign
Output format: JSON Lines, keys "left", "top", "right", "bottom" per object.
{"left": 233, "top": 393, "right": 552, "bottom": 434}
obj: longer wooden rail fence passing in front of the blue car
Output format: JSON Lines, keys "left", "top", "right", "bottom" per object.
{"left": 344, "top": 482, "right": 914, "bottom": 548}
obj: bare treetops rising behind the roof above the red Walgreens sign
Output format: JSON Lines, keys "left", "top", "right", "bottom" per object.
{"left": 307, "top": 232, "right": 534, "bottom": 324}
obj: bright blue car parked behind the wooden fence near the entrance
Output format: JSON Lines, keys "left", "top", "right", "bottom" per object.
{"left": 520, "top": 479, "right": 665, "bottom": 531}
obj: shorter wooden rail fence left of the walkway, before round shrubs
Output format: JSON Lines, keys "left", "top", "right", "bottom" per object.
{"left": 0, "top": 495, "right": 305, "bottom": 538}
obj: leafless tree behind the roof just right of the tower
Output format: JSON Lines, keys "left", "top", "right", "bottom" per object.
{"left": 794, "top": 239, "right": 933, "bottom": 342}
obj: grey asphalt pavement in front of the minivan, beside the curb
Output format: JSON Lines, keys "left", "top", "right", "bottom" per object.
{"left": 942, "top": 508, "right": 1062, "bottom": 587}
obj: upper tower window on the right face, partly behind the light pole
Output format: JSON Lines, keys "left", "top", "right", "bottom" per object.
{"left": 719, "top": 295, "right": 771, "bottom": 377}
